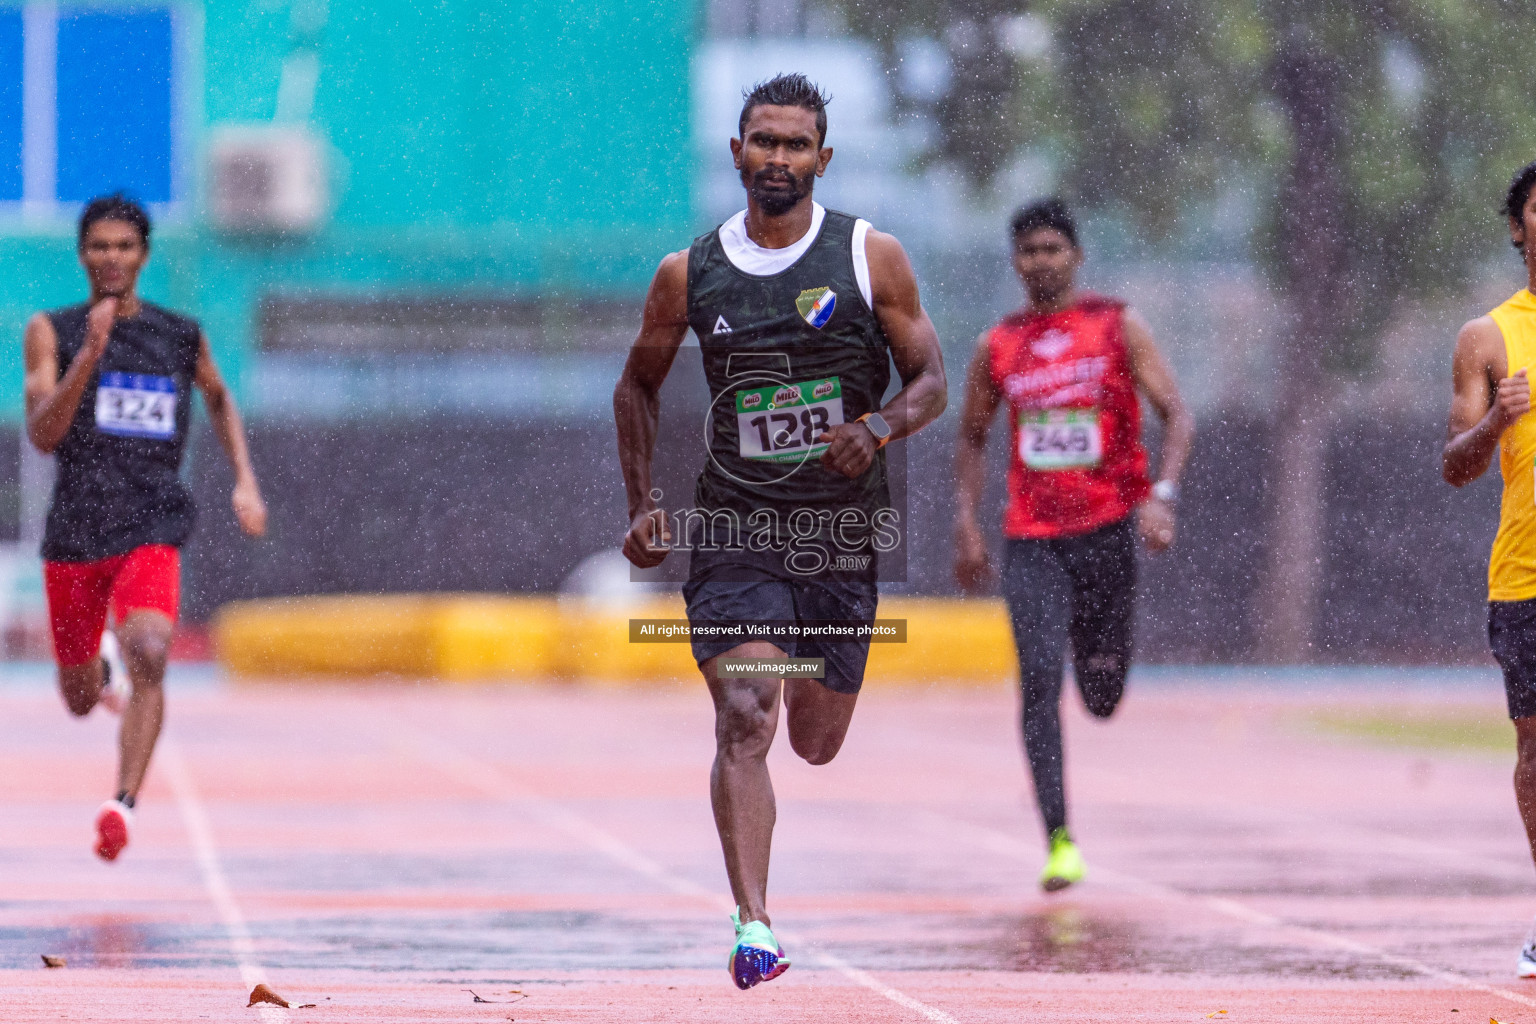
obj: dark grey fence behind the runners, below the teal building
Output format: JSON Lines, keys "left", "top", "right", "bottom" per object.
{"left": 158, "top": 410, "right": 1499, "bottom": 663}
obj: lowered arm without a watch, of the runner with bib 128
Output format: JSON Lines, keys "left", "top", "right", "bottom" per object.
{"left": 613, "top": 250, "right": 688, "bottom": 570}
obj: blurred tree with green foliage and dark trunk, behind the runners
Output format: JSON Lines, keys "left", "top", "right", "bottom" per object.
{"left": 843, "top": 0, "right": 1536, "bottom": 660}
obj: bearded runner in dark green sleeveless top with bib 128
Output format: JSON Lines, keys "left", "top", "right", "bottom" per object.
{"left": 613, "top": 75, "right": 946, "bottom": 989}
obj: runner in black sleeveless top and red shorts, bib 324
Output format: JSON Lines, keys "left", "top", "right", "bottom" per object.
{"left": 26, "top": 197, "right": 267, "bottom": 860}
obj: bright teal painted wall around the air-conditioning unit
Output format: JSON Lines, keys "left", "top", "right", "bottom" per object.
{"left": 0, "top": 0, "right": 696, "bottom": 419}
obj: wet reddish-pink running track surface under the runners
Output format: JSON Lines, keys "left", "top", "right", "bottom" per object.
{"left": 0, "top": 668, "right": 1536, "bottom": 1024}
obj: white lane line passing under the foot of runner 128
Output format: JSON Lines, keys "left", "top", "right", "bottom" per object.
{"left": 395, "top": 731, "right": 960, "bottom": 1024}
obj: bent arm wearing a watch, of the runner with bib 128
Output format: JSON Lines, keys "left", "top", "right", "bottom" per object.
{"left": 822, "top": 230, "right": 949, "bottom": 477}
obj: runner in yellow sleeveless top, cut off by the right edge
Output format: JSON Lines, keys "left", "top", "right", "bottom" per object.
{"left": 1441, "top": 161, "right": 1536, "bottom": 978}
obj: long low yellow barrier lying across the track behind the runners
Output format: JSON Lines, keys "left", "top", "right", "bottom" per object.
{"left": 214, "top": 594, "right": 1017, "bottom": 686}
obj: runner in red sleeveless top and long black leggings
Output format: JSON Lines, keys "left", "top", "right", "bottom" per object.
{"left": 955, "top": 200, "right": 1195, "bottom": 892}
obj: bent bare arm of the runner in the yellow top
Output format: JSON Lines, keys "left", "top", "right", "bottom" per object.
{"left": 1441, "top": 316, "right": 1531, "bottom": 487}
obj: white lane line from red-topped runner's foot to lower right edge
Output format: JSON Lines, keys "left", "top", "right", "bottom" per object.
{"left": 915, "top": 811, "right": 1536, "bottom": 1007}
